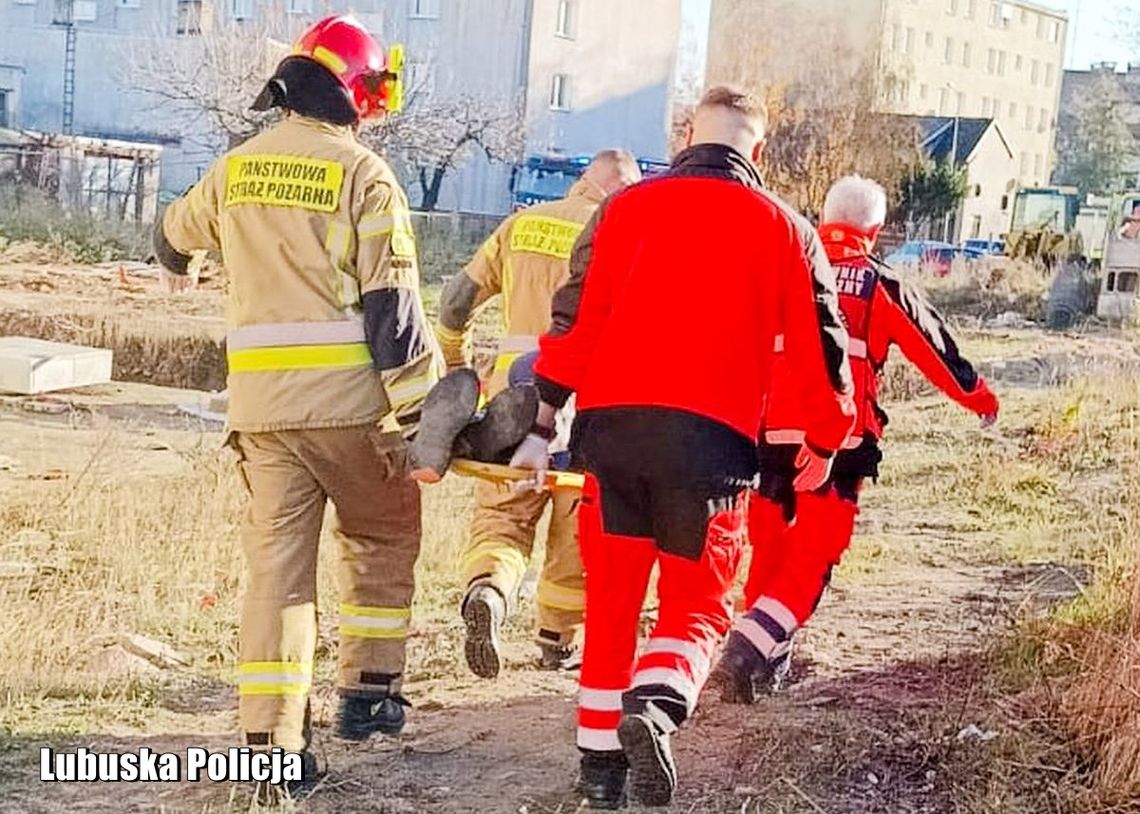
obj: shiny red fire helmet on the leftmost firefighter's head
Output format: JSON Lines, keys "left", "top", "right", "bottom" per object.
{"left": 293, "top": 15, "right": 404, "bottom": 119}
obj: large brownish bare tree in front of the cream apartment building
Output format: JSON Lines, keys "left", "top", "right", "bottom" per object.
{"left": 709, "top": 0, "right": 920, "bottom": 213}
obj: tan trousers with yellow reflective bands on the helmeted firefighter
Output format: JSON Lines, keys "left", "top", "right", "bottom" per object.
{"left": 230, "top": 426, "right": 420, "bottom": 750}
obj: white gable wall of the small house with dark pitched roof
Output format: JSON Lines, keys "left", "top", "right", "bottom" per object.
{"left": 958, "top": 124, "right": 1018, "bottom": 239}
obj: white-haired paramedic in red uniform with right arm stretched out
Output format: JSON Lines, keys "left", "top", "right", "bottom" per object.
{"left": 715, "top": 176, "right": 998, "bottom": 703}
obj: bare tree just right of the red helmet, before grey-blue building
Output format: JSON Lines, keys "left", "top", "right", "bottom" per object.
{"left": 364, "top": 92, "right": 526, "bottom": 211}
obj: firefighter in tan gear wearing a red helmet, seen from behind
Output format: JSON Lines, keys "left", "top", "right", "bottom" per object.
{"left": 155, "top": 17, "right": 439, "bottom": 773}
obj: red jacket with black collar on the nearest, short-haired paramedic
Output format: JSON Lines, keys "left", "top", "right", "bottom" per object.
{"left": 535, "top": 145, "right": 855, "bottom": 450}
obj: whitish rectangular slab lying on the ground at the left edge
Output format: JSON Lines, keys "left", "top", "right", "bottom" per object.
{"left": 0, "top": 336, "right": 112, "bottom": 396}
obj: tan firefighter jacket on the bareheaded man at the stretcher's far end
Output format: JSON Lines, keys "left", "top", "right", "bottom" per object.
{"left": 435, "top": 179, "right": 605, "bottom": 394}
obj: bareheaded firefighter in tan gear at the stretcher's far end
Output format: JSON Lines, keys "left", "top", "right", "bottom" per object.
{"left": 435, "top": 149, "right": 641, "bottom": 678}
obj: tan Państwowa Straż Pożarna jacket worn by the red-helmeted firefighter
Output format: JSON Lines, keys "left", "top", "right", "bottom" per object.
{"left": 162, "top": 116, "right": 439, "bottom": 433}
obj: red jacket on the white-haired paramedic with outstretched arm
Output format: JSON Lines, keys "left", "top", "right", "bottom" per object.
{"left": 764, "top": 218, "right": 998, "bottom": 449}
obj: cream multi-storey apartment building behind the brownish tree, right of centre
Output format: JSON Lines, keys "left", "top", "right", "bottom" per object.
{"left": 709, "top": 0, "right": 1067, "bottom": 186}
